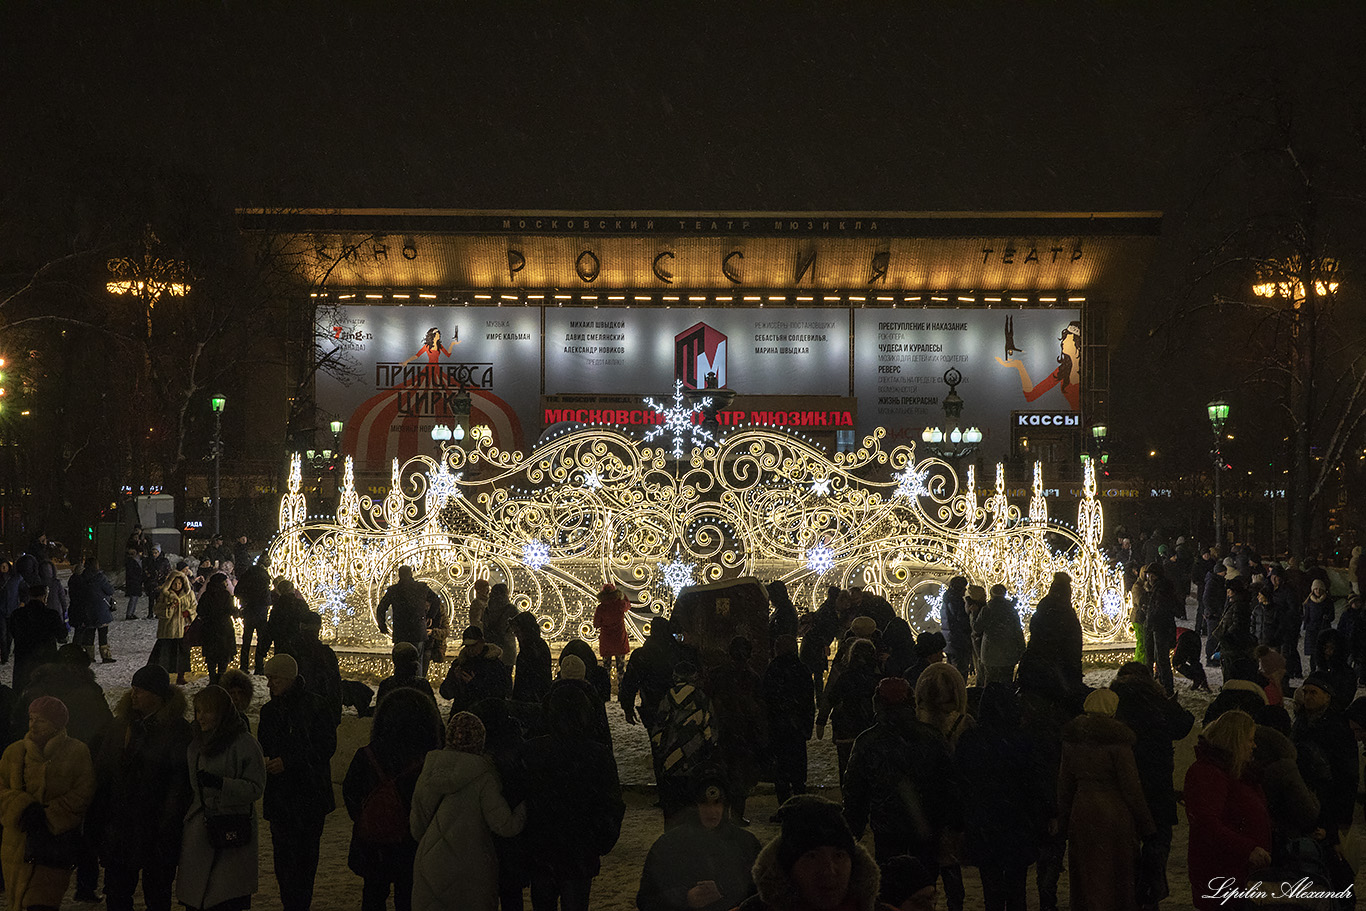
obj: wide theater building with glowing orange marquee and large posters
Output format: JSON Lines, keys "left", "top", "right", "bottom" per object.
{"left": 239, "top": 209, "right": 1161, "bottom": 485}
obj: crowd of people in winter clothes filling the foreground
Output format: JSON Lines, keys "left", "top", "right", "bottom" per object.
{"left": 0, "top": 527, "right": 1366, "bottom": 911}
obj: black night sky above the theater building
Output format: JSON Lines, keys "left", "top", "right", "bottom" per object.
{"left": 0, "top": 1, "right": 1366, "bottom": 469}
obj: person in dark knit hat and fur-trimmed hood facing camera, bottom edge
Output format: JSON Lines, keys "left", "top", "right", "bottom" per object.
{"left": 736, "top": 795, "right": 896, "bottom": 911}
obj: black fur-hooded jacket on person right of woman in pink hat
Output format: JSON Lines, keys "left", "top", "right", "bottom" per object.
{"left": 86, "top": 687, "right": 194, "bottom": 867}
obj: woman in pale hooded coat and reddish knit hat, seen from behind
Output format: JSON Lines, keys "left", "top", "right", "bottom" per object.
{"left": 408, "top": 712, "right": 526, "bottom": 911}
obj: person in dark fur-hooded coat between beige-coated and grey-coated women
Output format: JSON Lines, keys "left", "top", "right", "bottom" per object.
{"left": 86, "top": 664, "right": 194, "bottom": 911}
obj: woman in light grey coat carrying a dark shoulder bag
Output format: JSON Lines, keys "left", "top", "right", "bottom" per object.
{"left": 176, "top": 687, "right": 265, "bottom": 911}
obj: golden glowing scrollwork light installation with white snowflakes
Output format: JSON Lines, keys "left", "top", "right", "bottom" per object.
{"left": 269, "top": 423, "right": 1128, "bottom": 650}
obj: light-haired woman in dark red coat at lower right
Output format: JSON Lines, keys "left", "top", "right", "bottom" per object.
{"left": 1186, "top": 709, "right": 1272, "bottom": 911}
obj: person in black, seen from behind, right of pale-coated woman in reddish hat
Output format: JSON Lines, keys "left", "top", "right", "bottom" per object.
{"left": 522, "top": 687, "right": 626, "bottom": 911}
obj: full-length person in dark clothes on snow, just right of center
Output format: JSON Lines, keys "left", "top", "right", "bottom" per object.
{"left": 759, "top": 635, "right": 816, "bottom": 808}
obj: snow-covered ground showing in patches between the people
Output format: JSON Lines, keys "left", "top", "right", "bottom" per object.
{"left": 0, "top": 605, "right": 1366, "bottom": 911}
